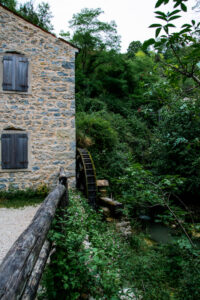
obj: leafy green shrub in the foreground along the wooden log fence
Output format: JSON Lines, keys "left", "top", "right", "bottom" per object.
{"left": 41, "top": 195, "right": 137, "bottom": 300}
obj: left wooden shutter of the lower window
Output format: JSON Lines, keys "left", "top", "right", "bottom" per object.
{"left": 1, "top": 134, "right": 14, "bottom": 169}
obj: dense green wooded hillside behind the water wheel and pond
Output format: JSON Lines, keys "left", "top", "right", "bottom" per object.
{"left": 69, "top": 1, "right": 200, "bottom": 201}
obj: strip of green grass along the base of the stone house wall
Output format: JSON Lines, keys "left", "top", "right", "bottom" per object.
{"left": 0, "top": 186, "right": 48, "bottom": 208}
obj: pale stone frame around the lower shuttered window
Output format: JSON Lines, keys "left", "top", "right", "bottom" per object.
{"left": 0, "top": 130, "right": 32, "bottom": 173}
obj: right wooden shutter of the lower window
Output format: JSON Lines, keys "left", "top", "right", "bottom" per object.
{"left": 15, "top": 134, "right": 28, "bottom": 169}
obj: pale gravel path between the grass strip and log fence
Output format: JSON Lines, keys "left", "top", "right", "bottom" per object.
{"left": 0, "top": 205, "right": 40, "bottom": 263}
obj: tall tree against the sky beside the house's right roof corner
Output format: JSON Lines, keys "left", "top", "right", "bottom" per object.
{"left": 61, "top": 8, "right": 120, "bottom": 97}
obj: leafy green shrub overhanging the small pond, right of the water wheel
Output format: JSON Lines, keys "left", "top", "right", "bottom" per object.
{"left": 118, "top": 162, "right": 186, "bottom": 222}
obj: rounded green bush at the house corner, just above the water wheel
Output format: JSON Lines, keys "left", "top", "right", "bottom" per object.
{"left": 77, "top": 113, "right": 129, "bottom": 190}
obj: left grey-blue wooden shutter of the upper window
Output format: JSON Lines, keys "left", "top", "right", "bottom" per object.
{"left": 3, "top": 56, "right": 15, "bottom": 91}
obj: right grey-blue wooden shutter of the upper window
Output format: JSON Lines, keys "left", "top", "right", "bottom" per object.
{"left": 15, "top": 56, "right": 28, "bottom": 92}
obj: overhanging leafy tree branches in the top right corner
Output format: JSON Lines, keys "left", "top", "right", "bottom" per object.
{"left": 146, "top": 0, "right": 200, "bottom": 87}
